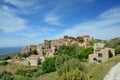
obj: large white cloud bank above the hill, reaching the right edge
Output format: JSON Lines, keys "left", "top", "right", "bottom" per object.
{"left": 57, "top": 8, "right": 120, "bottom": 39}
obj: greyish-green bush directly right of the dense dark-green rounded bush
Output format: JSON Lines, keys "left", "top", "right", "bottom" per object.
{"left": 55, "top": 54, "right": 70, "bottom": 69}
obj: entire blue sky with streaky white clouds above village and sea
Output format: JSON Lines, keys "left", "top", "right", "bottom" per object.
{"left": 0, "top": 0, "right": 120, "bottom": 47}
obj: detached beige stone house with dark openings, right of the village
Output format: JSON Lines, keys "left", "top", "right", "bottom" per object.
{"left": 89, "top": 43, "right": 115, "bottom": 63}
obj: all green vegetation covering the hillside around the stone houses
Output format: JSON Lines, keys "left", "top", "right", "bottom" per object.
{"left": 0, "top": 38, "right": 120, "bottom": 80}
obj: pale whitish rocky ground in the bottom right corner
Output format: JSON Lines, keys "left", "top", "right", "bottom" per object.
{"left": 104, "top": 62, "right": 120, "bottom": 80}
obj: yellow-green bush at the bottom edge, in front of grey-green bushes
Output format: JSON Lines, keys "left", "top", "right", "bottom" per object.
{"left": 58, "top": 69, "right": 90, "bottom": 80}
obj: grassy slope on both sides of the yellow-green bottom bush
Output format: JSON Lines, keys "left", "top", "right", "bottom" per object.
{"left": 36, "top": 55, "right": 120, "bottom": 80}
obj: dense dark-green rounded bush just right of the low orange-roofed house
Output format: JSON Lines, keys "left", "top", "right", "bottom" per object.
{"left": 42, "top": 57, "right": 56, "bottom": 73}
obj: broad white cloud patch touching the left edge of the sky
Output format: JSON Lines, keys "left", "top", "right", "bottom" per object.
{"left": 0, "top": 6, "right": 27, "bottom": 33}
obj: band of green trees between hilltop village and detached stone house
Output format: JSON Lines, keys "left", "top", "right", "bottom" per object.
{"left": 57, "top": 45, "right": 93, "bottom": 60}
